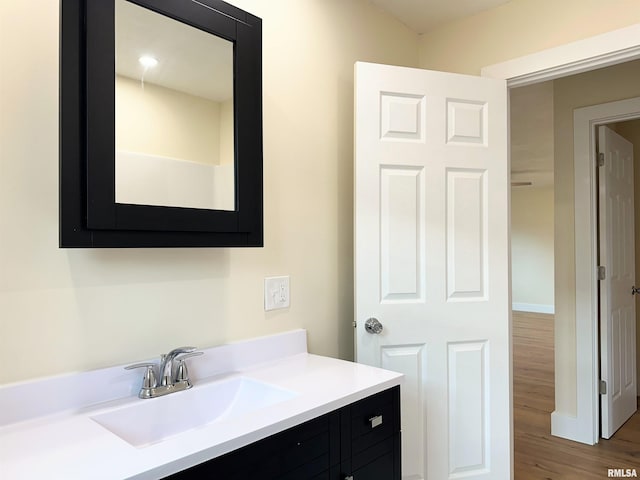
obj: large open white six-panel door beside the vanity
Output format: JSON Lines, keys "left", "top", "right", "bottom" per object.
{"left": 355, "top": 62, "right": 512, "bottom": 480}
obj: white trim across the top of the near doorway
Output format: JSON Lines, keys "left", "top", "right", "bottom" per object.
{"left": 481, "top": 23, "right": 640, "bottom": 87}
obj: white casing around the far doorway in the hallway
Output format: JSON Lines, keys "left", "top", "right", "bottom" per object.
{"left": 568, "top": 97, "right": 640, "bottom": 443}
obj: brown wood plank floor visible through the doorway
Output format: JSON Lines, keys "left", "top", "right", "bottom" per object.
{"left": 513, "top": 312, "right": 640, "bottom": 480}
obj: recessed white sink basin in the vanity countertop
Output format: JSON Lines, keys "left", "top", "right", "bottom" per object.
{"left": 91, "top": 377, "right": 297, "bottom": 447}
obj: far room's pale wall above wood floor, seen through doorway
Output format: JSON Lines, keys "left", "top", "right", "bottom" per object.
{"left": 511, "top": 186, "right": 554, "bottom": 309}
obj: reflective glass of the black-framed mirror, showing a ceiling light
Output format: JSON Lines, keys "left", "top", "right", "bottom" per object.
{"left": 115, "top": 0, "right": 235, "bottom": 210}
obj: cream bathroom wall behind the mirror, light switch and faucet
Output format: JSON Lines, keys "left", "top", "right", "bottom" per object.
{"left": 0, "top": 0, "right": 418, "bottom": 383}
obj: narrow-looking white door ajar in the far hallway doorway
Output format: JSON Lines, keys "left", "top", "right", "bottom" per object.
{"left": 598, "top": 126, "right": 637, "bottom": 438}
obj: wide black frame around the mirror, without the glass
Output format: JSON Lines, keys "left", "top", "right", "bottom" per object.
{"left": 59, "top": 0, "right": 263, "bottom": 247}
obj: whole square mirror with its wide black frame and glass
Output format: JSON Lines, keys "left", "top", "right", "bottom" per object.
{"left": 60, "top": 0, "right": 263, "bottom": 247}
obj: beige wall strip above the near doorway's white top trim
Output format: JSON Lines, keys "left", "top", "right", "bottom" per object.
{"left": 420, "top": 0, "right": 640, "bottom": 74}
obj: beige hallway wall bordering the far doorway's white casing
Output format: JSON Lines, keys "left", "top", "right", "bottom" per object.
{"left": 554, "top": 60, "right": 640, "bottom": 414}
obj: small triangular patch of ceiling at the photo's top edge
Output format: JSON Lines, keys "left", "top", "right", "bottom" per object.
{"left": 370, "top": 0, "right": 510, "bottom": 33}
